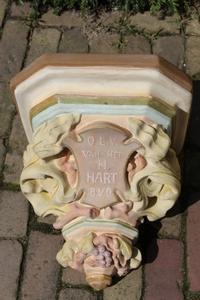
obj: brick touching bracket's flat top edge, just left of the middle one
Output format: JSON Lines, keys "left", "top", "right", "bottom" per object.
{"left": 59, "top": 28, "right": 88, "bottom": 53}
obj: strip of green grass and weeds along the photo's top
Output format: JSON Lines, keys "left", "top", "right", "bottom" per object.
{"left": 15, "top": 0, "right": 200, "bottom": 18}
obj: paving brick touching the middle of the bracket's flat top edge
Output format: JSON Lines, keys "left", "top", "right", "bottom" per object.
{"left": 90, "top": 33, "right": 119, "bottom": 54}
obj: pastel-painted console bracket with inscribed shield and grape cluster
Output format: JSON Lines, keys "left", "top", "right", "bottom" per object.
{"left": 11, "top": 54, "right": 192, "bottom": 290}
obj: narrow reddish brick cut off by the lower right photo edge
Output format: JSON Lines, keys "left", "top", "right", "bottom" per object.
{"left": 187, "top": 201, "right": 200, "bottom": 291}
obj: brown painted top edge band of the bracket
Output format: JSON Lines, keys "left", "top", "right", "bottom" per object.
{"left": 10, "top": 53, "right": 192, "bottom": 93}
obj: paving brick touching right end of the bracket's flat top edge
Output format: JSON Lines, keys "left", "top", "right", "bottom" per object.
{"left": 122, "top": 35, "right": 151, "bottom": 54}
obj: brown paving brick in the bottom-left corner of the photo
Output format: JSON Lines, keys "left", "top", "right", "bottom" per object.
{"left": 0, "top": 240, "right": 22, "bottom": 300}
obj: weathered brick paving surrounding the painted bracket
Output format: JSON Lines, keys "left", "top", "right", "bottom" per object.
{"left": 0, "top": 0, "right": 200, "bottom": 300}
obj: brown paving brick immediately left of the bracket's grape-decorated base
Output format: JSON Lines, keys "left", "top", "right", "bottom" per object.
{"left": 21, "top": 231, "right": 61, "bottom": 300}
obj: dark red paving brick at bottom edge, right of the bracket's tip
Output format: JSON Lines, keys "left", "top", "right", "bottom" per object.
{"left": 144, "top": 240, "right": 183, "bottom": 300}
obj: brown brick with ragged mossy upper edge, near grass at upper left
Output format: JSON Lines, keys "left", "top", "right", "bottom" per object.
{"left": 41, "top": 10, "right": 84, "bottom": 28}
